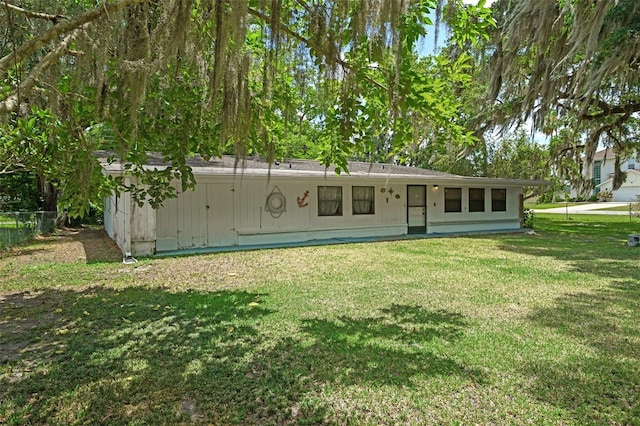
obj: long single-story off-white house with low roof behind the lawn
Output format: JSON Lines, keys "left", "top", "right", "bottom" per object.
{"left": 102, "top": 155, "right": 547, "bottom": 256}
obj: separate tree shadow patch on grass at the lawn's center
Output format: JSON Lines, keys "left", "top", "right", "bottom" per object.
{"left": 292, "top": 305, "right": 484, "bottom": 386}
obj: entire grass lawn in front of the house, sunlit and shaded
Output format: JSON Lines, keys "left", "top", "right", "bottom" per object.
{"left": 0, "top": 218, "right": 640, "bottom": 425}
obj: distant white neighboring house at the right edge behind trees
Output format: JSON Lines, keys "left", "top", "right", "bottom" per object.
{"left": 592, "top": 148, "right": 640, "bottom": 202}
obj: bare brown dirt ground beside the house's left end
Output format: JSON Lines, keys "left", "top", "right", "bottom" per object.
{"left": 0, "top": 228, "right": 122, "bottom": 263}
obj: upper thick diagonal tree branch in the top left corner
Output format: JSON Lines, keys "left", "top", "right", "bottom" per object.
{"left": 0, "top": 0, "right": 145, "bottom": 75}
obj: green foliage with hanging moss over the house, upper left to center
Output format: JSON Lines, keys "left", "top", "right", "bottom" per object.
{"left": 0, "top": 0, "right": 492, "bottom": 213}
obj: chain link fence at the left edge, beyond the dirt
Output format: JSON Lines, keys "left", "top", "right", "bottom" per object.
{"left": 0, "top": 212, "right": 57, "bottom": 250}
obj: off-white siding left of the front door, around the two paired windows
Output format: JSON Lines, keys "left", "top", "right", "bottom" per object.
{"left": 152, "top": 176, "right": 416, "bottom": 252}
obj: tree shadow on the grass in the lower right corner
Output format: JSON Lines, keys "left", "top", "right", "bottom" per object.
{"left": 526, "top": 280, "right": 640, "bottom": 424}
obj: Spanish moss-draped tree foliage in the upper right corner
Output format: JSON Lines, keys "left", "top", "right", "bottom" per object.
{"left": 484, "top": 0, "right": 640, "bottom": 196}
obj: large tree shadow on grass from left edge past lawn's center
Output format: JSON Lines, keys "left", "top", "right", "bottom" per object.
{"left": 0, "top": 287, "right": 476, "bottom": 424}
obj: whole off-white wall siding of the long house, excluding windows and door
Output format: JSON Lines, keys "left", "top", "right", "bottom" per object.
{"left": 127, "top": 175, "right": 522, "bottom": 256}
